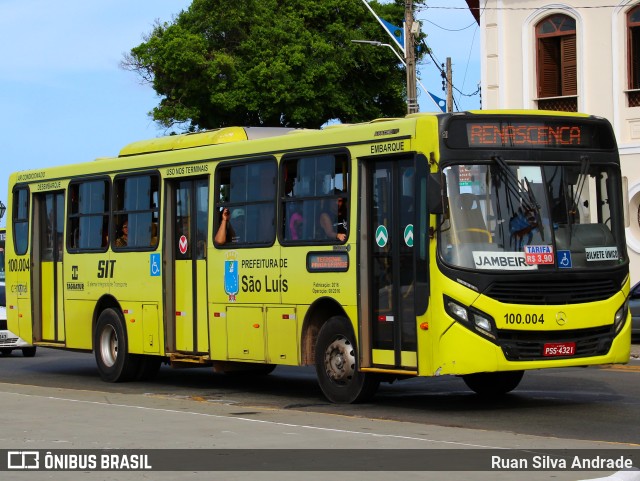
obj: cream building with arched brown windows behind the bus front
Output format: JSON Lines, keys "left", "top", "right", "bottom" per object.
{"left": 467, "top": 0, "right": 640, "bottom": 285}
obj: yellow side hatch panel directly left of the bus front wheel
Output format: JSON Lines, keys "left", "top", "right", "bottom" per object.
{"left": 267, "top": 307, "right": 300, "bottom": 366}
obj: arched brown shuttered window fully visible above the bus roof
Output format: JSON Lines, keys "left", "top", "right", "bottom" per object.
{"left": 536, "top": 14, "right": 578, "bottom": 112}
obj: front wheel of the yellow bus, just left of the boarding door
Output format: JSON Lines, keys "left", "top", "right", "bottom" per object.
{"left": 316, "top": 316, "right": 380, "bottom": 403}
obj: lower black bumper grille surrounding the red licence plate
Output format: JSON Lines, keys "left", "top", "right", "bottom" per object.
{"left": 498, "top": 327, "right": 614, "bottom": 361}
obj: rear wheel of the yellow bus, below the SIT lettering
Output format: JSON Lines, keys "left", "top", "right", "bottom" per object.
{"left": 93, "top": 309, "right": 140, "bottom": 382}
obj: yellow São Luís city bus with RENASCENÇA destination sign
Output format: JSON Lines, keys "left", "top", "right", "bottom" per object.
{"left": 6, "top": 111, "right": 631, "bottom": 402}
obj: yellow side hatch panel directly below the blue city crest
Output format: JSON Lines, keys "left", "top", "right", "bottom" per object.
{"left": 227, "top": 306, "right": 266, "bottom": 361}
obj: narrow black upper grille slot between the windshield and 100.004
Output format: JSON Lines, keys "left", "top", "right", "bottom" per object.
{"left": 484, "top": 279, "right": 620, "bottom": 305}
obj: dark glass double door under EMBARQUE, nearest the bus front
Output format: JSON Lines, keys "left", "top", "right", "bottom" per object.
{"left": 360, "top": 158, "right": 417, "bottom": 371}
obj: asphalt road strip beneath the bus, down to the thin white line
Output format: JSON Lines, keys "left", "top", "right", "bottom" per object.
{"left": 0, "top": 345, "right": 640, "bottom": 446}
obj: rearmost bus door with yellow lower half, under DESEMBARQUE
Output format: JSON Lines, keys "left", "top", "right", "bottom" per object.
{"left": 31, "top": 192, "right": 65, "bottom": 343}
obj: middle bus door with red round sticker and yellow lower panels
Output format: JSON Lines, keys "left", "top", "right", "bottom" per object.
{"left": 165, "top": 178, "right": 209, "bottom": 354}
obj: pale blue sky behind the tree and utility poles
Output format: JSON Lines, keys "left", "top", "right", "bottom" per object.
{"left": 0, "top": 0, "right": 480, "bottom": 226}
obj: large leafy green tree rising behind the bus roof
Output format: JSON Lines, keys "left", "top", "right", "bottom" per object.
{"left": 122, "top": 0, "right": 423, "bottom": 131}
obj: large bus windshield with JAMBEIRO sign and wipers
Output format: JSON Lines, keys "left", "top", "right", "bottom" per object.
{"left": 439, "top": 157, "right": 626, "bottom": 271}
